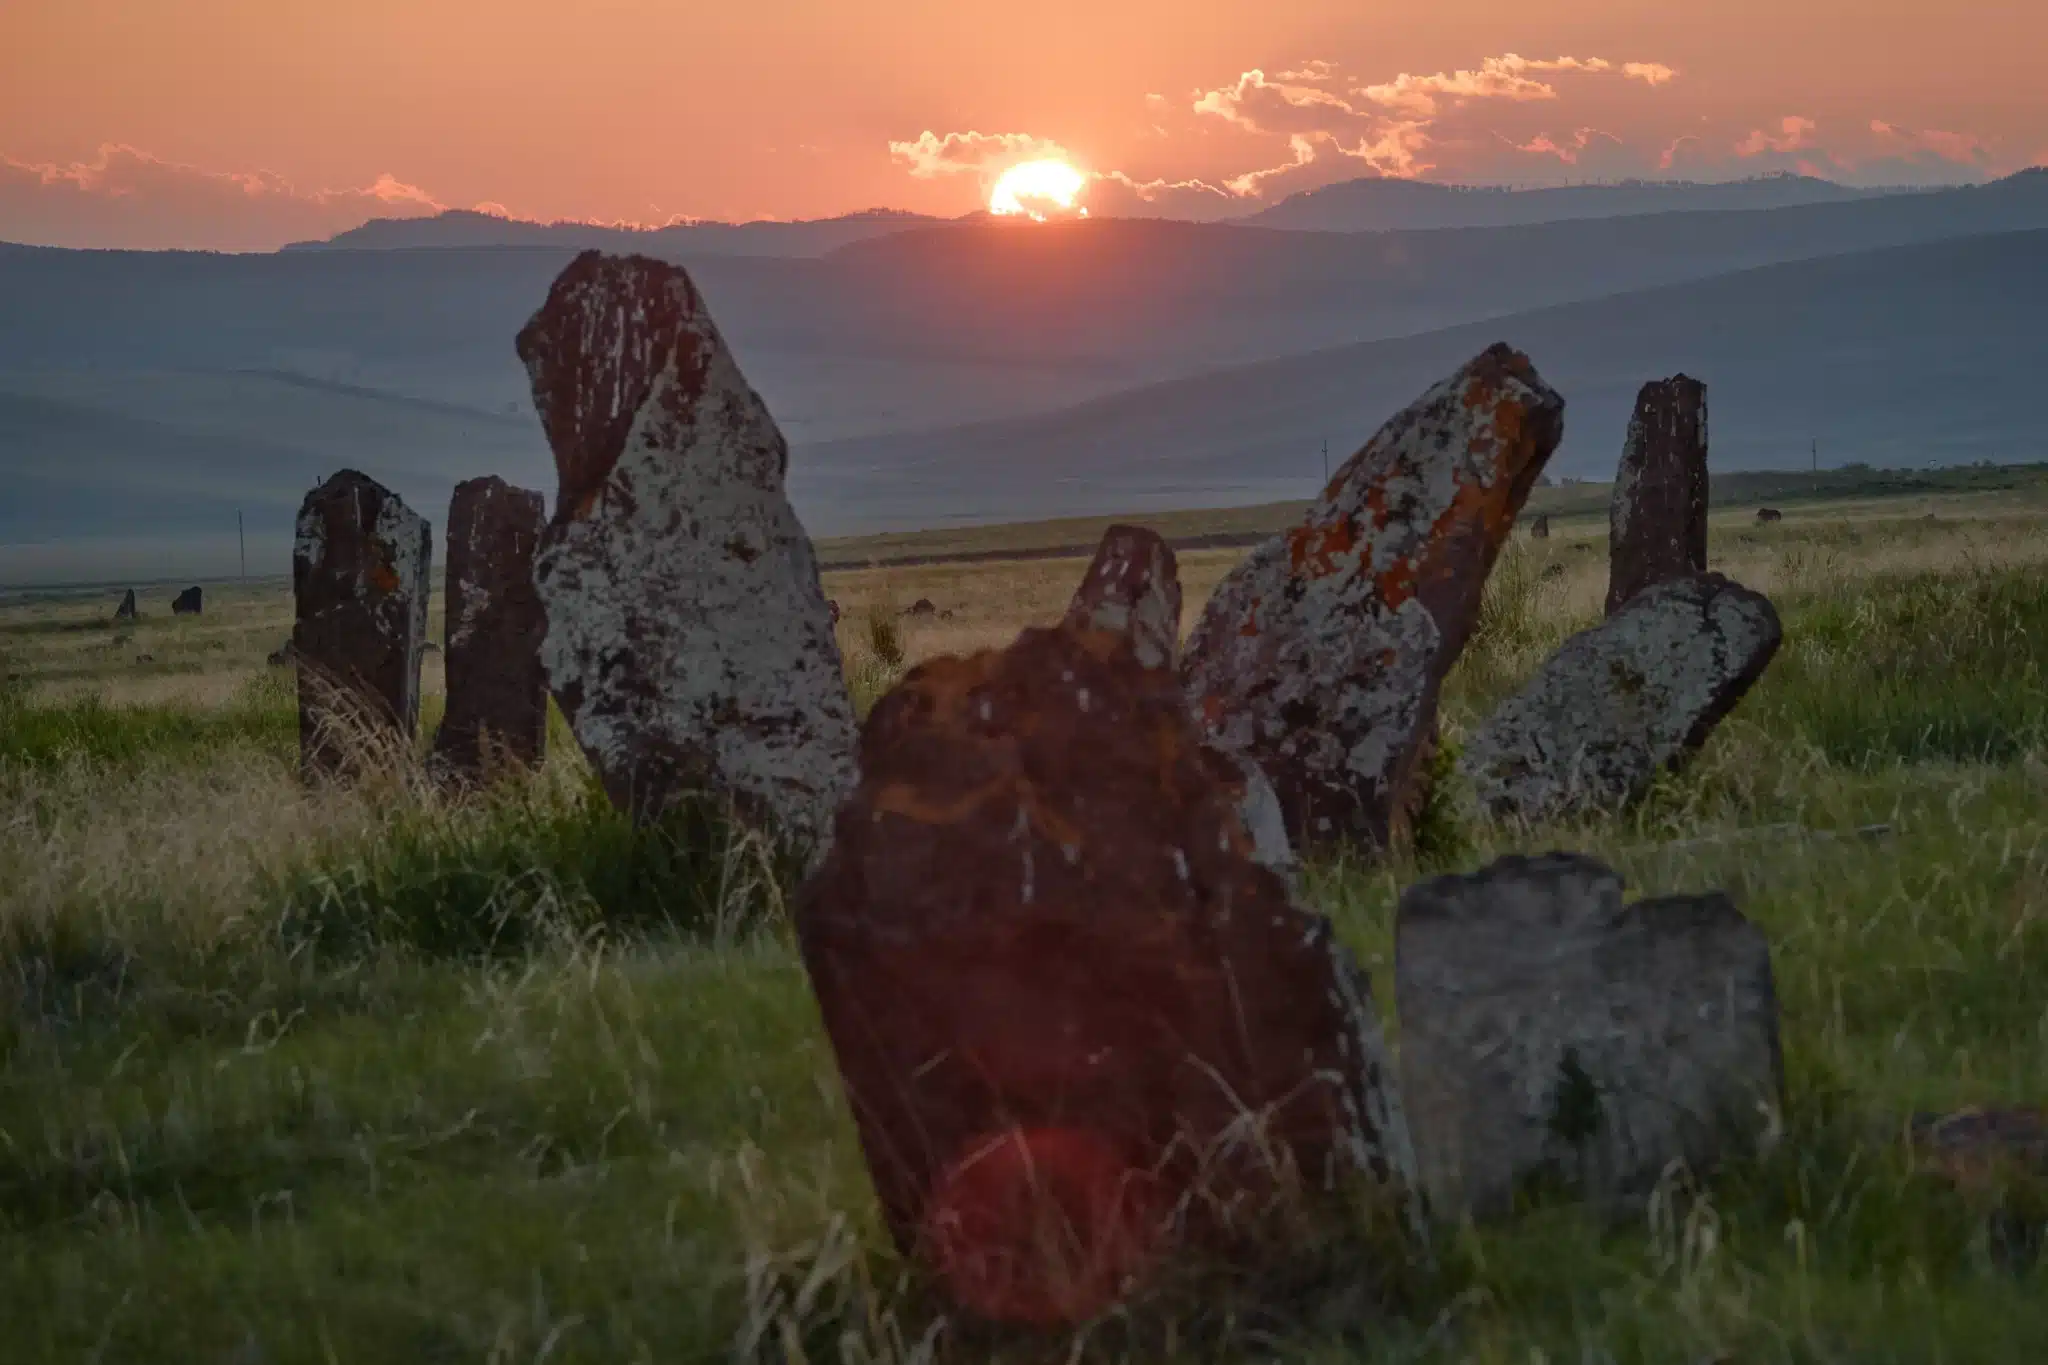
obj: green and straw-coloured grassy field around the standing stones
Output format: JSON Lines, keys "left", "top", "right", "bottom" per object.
{"left": 0, "top": 473, "right": 2048, "bottom": 1365}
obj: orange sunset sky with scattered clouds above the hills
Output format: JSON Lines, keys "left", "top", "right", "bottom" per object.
{"left": 0, "top": 0, "right": 2048, "bottom": 248}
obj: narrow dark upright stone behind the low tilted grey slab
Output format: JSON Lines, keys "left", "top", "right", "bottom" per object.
{"left": 1608, "top": 375, "right": 1706, "bottom": 616}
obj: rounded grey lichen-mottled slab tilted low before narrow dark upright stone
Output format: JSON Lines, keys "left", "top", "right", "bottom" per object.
{"left": 1458, "top": 573, "right": 1784, "bottom": 821}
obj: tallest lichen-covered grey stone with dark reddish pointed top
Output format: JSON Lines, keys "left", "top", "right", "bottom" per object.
{"left": 518, "top": 252, "right": 854, "bottom": 843}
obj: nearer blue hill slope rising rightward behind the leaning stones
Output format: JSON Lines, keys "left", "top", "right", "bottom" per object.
{"left": 791, "top": 231, "right": 2048, "bottom": 532}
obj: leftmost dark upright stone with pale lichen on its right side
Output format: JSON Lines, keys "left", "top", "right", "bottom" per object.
{"left": 291, "top": 469, "right": 432, "bottom": 778}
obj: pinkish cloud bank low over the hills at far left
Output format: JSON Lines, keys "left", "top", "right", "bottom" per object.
{"left": 0, "top": 143, "right": 446, "bottom": 252}
